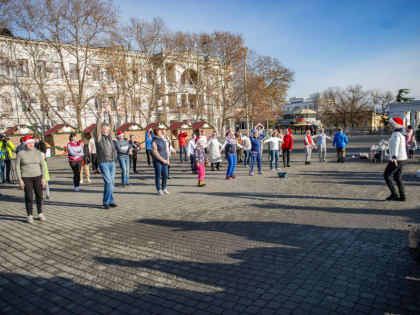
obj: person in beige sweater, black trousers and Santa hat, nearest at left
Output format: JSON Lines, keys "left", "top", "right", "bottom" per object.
{"left": 16, "top": 136, "right": 45, "bottom": 223}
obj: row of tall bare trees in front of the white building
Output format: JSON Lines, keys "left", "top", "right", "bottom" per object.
{"left": 0, "top": 0, "right": 293, "bottom": 130}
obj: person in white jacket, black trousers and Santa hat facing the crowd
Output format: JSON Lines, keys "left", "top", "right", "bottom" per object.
{"left": 384, "top": 117, "right": 407, "bottom": 201}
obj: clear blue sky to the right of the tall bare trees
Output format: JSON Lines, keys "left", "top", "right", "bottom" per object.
{"left": 115, "top": 0, "right": 420, "bottom": 99}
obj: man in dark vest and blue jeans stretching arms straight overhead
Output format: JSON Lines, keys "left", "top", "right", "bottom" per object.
{"left": 94, "top": 106, "right": 117, "bottom": 209}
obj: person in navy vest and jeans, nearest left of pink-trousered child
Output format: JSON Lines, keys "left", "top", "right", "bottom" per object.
{"left": 152, "top": 128, "right": 169, "bottom": 196}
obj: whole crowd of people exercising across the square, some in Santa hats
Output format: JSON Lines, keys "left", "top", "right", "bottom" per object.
{"left": 0, "top": 108, "right": 416, "bottom": 223}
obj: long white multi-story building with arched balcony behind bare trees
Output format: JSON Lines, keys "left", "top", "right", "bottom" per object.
{"left": 0, "top": 36, "right": 231, "bottom": 131}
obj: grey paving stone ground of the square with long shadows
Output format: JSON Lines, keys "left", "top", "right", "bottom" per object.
{"left": 0, "top": 136, "right": 420, "bottom": 314}
